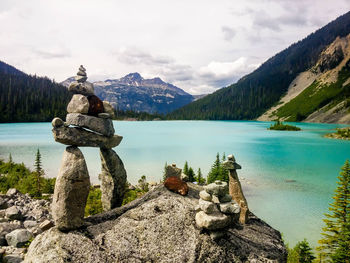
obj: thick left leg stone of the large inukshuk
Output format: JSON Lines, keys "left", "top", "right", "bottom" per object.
{"left": 52, "top": 146, "right": 90, "bottom": 230}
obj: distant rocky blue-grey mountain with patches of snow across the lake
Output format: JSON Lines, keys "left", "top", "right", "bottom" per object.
{"left": 61, "top": 72, "right": 195, "bottom": 114}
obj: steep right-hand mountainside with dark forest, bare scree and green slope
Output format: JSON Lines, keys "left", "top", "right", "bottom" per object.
{"left": 167, "top": 12, "right": 350, "bottom": 123}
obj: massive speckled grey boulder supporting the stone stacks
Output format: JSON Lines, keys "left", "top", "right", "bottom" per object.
{"left": 25, "top": 184, "right": 287, "bottom": 263}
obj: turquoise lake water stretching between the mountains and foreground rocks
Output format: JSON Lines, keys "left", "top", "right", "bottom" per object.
{"left": 0, "top": 121, "right": 350, "bottom": 249}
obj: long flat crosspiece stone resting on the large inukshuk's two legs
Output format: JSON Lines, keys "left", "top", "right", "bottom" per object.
{"left": 52, "top": 126, "right": 123, "bottom": 149}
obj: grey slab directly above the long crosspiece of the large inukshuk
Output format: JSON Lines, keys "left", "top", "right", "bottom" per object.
{"left": 66, "top": 113, "right": 114, "bottom": 137}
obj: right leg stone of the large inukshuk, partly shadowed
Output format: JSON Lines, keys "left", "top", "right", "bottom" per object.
{"left": 99, "top": 149, "right": 126, "bottom": 211}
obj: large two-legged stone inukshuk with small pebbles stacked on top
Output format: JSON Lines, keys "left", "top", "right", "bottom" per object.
{"left": 52, "top": 66, "right": 126, "bottom": 231}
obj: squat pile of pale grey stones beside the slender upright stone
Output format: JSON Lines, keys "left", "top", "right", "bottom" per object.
{"left": 196, "top": 181, "right": 240, "bottom": 239}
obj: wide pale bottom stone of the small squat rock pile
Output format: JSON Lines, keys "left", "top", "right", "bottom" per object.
{"left": 196, "top": 211, "right": 232, "bottom": 230}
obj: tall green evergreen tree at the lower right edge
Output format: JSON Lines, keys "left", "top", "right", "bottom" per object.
{"left": 317, "top": 160, "right": 350, "bottom": 263}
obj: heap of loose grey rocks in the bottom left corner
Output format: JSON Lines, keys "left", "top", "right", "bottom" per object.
{"left": 0, "top": 188, "right": 54, "bottom": 262}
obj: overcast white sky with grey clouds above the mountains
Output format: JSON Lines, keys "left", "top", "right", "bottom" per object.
{"left": 0, "top": 0, "right": 350, "bottom": 94}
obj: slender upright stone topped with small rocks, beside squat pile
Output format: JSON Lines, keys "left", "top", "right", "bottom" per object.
{"left": 224, "top": 154, "right": 249, "bottom": 224}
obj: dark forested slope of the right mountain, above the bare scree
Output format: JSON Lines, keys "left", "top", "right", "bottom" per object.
{"left": 167, "top": 12, "right": 350, "bottom": 120}
